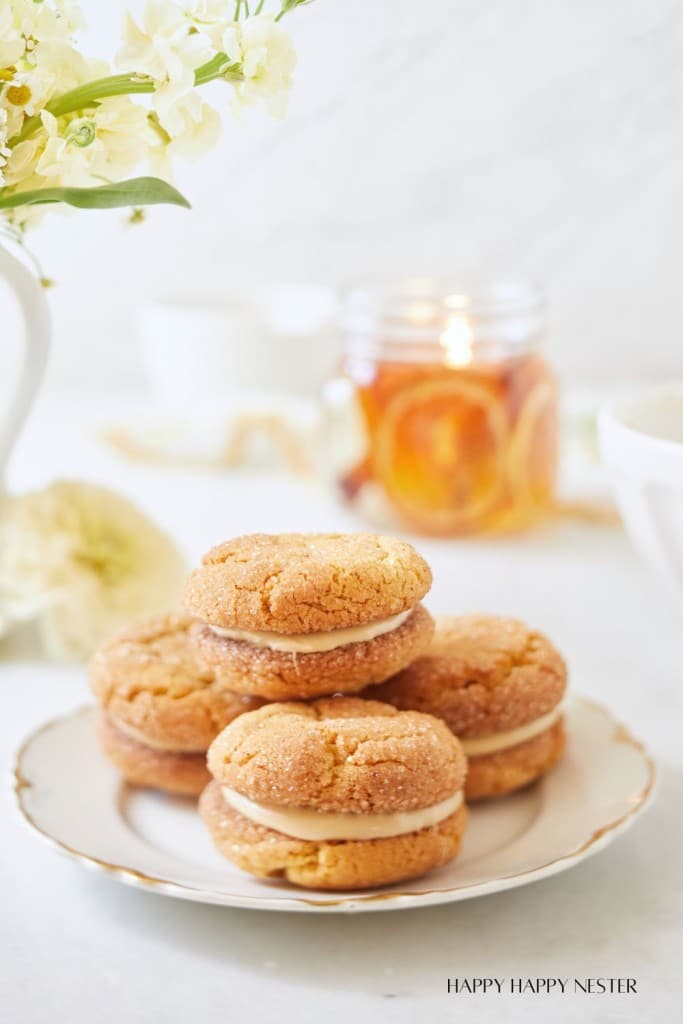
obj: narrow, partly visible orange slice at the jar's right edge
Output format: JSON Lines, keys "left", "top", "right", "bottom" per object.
{"left": 508, "top": 379, "right": 557, "bottom": 518}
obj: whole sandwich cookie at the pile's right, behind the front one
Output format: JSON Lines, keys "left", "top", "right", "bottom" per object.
{"left": 364, "top": 615, "right": 566, "bottom": 800}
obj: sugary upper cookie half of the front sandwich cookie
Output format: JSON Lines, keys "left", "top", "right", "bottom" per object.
{"left": 208, "top": 697, "right": 466, "bottom": 813}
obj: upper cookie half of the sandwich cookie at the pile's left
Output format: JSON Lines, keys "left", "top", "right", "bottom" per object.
{"left": 90, "top": 615, "right": 263, "bottom": 753}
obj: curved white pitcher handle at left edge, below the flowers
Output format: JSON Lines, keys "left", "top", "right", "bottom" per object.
{"left": 0, "top": 245, "right": 50, "bottom": 493}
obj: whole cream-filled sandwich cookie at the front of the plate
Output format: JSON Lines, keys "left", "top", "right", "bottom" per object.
{"left": 200, "top": 697, "right": 467, "bottom": 890}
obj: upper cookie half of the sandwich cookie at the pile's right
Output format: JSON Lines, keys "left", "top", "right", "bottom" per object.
{"left": 364, "top": 615, "right": 567, "bottom": 739}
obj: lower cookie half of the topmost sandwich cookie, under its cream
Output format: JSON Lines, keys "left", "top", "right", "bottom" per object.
{"left": 194, "top": 604, "right": 434, "bottom": 700}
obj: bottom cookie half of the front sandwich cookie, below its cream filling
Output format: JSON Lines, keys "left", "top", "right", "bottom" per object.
{"left": 194, "top": 782, "right": 467, "bottom": 890}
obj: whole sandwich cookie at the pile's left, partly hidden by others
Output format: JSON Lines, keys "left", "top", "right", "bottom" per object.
{"left": 90, "top": 615, "right": 263, "bottom": 796}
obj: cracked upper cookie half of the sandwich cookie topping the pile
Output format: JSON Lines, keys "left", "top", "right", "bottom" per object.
{"left": 185, "top": 534, "right": 432, "bottom": 633}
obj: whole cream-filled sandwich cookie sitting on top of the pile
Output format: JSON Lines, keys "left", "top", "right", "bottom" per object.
{"left": 185, "top": 534, "right": 433, "bottom": 700}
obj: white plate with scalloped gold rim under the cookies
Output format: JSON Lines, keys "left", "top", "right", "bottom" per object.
{"left": 15, "top": 697, "right": 654, "bottom": 911}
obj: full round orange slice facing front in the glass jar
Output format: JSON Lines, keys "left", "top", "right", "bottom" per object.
{"left": 373, "top": 373, "right": 508, "bottom": 535}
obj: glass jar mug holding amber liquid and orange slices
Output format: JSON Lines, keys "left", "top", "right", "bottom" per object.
{"left": 326, "top": 279, "right": 557, "bottom": 536}
